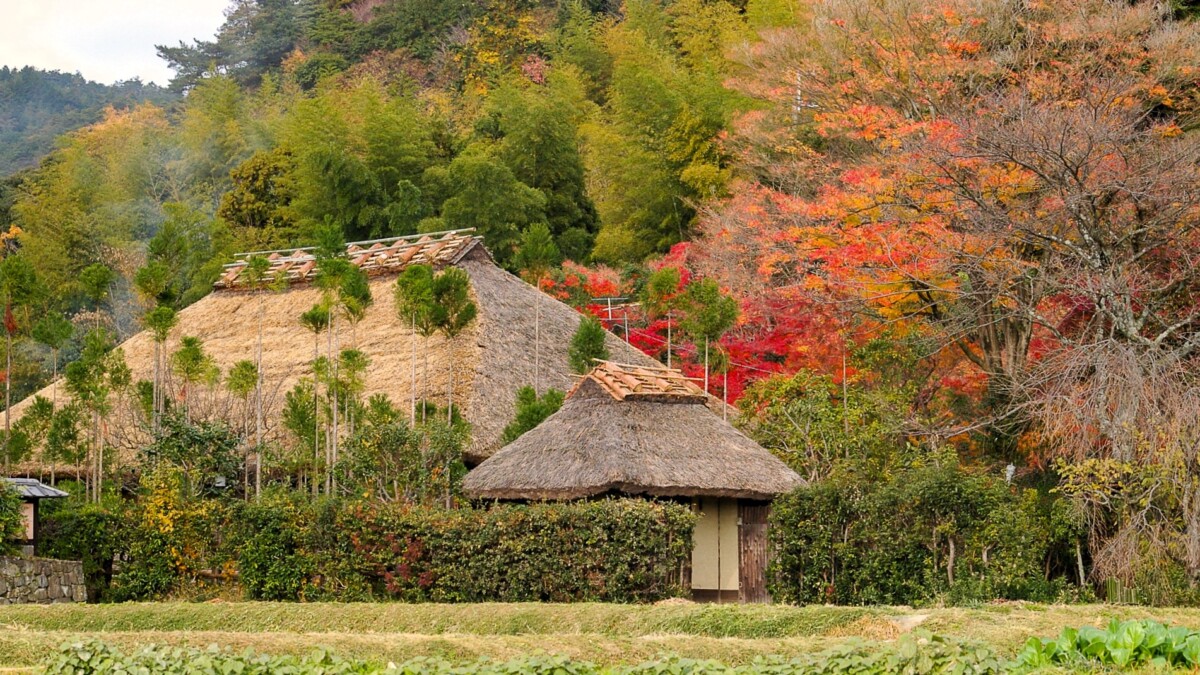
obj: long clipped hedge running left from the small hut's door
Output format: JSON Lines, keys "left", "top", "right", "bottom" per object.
{"left": 47, "top": 491, "right": 695, "bottom": 603}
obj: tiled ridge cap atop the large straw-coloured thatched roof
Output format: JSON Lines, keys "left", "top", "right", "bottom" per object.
{"left": 212, "top": 229, "right": 479, "bottom": 288}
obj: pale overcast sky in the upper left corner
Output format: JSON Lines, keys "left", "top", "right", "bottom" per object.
{"left": 0, "top": 0, "right": 229, "bottom": 85}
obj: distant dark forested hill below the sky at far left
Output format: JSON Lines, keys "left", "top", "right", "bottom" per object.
{"left": 0, "top": 66, "right": 175, "bottom": 177}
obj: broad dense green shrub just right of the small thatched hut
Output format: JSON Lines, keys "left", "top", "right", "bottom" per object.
{"left": 769, "top": 460, "right": 1079, "bottom": 604}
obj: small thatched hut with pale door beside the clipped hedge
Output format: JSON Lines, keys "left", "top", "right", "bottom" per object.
{"left": 463, "top": 362, "right": 804, "bottom": 602}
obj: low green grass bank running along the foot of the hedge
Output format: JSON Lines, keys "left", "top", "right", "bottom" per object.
{"left": 0, "top": 603, "right": 881, "bottom": 639}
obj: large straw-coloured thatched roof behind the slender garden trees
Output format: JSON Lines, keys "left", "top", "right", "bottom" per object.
{"left": 13, "top": 228, "right": 656, "bottom": 461}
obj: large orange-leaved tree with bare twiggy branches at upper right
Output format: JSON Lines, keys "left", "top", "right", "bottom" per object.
{"left": 696, "top": 0, "right": 1200, "bottom": 459}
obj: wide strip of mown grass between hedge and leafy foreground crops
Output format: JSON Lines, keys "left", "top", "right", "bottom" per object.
{"left": 0, "top": 602, "right": 1200, "bottom": 671}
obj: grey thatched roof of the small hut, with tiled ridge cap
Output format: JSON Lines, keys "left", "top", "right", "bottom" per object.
{"left": 463, "top": 363, "right": 803, "bottom": 500}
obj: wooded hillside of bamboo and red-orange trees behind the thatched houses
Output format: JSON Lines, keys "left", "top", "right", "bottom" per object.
{"left": 7, "top": 0, "right": 1200, "bottom": 603}
